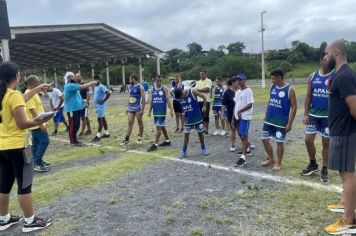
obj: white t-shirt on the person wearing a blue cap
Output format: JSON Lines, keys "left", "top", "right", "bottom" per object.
{"left": 234, "top": 88, "right": 255, "bottom": 120}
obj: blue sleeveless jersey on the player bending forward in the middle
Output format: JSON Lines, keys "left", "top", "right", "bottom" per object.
{"left": 179, "top": 89, "right": 203, "bottom": 125}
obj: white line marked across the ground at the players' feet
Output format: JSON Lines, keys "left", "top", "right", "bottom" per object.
{"left": 52, "top": 138, "right": 343, "bottom": 193}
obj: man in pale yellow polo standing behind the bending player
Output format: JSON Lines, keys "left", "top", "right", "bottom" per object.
{"left": 195, "top": 69, "right": 213, "bottom": 135}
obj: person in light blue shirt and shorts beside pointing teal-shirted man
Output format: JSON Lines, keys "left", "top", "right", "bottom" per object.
{"left": 92, "top": 75, "right": 111, "bottom": 142}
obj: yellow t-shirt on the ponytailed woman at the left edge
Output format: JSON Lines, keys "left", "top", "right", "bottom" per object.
{"left": 0, "top": 89, "right": 27, "bottom": 150}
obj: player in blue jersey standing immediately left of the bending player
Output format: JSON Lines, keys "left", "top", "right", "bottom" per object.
{"left": 147, "top": 75, "right": 173, "bottom": 152}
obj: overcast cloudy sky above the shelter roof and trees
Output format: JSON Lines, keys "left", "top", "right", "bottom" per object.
{"left": 7, "top": 0, "right": 356, "bottom": 52}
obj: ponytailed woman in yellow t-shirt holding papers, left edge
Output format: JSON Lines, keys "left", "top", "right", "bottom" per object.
{"left": 0, "top": 62, "right": 51, "bottom": 232}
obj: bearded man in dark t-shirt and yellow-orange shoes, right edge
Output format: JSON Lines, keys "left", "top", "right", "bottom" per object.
{"left": 324, "top": 40, "right": 356, "bottom": 234}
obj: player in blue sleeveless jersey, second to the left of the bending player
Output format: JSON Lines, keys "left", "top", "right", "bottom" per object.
{"left": 121, "top": 75, "right": 146, "bottom": 145}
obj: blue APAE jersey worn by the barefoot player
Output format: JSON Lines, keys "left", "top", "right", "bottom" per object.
{"left": 265, "top": 84, "right": 291, "bottom": 128}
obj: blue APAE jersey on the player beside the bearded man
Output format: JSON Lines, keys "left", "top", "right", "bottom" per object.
{"left": 309, "top": 71, "right": 334, "bottom": 118}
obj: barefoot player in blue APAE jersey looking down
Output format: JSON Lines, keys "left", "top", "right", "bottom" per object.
{"left": 261, "top": 68, "right": 297, "bottom": 171}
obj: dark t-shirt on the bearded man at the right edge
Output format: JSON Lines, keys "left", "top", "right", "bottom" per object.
{"left": 329, "top": 64, "right": 356, "bottom": 136}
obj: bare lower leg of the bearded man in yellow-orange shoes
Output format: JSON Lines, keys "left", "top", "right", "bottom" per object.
{"left": 340, "top": 172, "right": 356, "bottom": 224}
